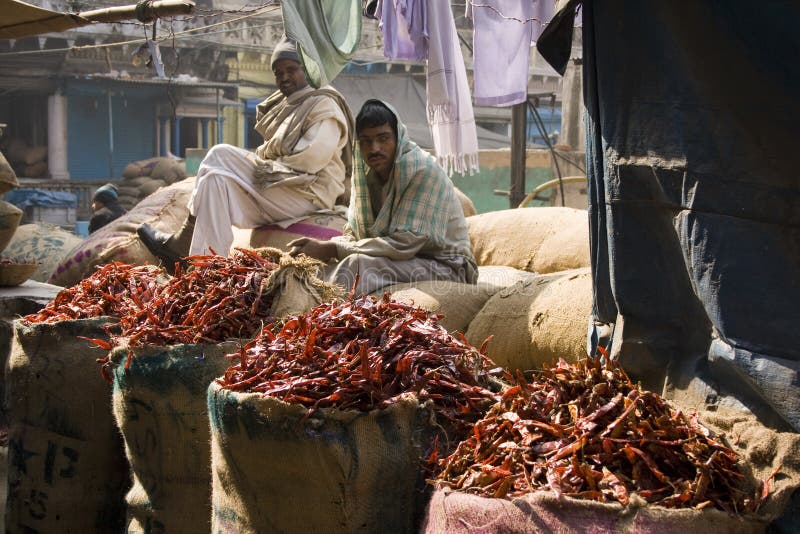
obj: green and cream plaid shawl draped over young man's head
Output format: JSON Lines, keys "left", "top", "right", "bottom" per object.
{"left": 347, "top": 102, "right": 455, "bottom": 247}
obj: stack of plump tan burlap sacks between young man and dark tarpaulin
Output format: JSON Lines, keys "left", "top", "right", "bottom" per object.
{"left": 375, "top": 207, "right": 592, "bottom": 371}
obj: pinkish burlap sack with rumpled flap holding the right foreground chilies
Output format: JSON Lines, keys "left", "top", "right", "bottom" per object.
{"left": 422, "top": 408, "right": 800, "bottom": 534}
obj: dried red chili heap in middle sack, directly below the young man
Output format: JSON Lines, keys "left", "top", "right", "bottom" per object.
{"left": 217, "top": 294, "right": 499, "bottom": 442}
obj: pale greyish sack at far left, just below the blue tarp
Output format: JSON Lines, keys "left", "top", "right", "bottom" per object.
{"left": 3, "top": 223, "right": 83, "bottom": 282}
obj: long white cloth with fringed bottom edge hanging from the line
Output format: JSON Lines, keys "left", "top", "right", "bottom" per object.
{"left": 427, "top": 0, "right": 478, "bottom": 175}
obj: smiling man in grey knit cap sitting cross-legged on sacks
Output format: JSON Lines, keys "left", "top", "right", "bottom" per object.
{"left": 137, "top": 38, "right": 353, "bottom": 270}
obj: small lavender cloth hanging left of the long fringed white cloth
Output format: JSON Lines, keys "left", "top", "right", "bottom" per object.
{"left": 375, "top": 0, "right": 428, "bottom": 61}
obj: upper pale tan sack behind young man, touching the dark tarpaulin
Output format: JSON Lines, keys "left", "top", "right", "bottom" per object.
{"left": 467, "top": 208, "right": 589, "bottom": 274}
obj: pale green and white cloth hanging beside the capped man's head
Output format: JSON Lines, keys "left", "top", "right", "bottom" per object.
{"left": 281, "top": 0, "right": 361, "bottom": 88}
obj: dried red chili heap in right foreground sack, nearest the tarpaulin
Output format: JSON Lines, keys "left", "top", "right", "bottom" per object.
{"left": 436, "top": 359, "right": 766, "bottom": 512}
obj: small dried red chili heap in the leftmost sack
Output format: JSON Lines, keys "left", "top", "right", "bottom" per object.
{"left": 22, "top": 262, "right": 163, "bottom": 324}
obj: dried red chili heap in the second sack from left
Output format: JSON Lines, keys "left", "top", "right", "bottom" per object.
{"left": 112, "top": 249, "right": 278, "bottom": 346}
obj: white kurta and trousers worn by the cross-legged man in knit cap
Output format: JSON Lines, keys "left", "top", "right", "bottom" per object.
{"left": 189, "top": 105, "right": 347, "bottom": 256}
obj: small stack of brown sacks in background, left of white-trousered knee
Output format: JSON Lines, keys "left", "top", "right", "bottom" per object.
{"left": 118, "top": 158, "right": 186, "bottom": 211}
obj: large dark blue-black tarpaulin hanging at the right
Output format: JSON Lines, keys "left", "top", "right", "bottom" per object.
{"left": 538, "top": 0, "right": 800, "bottom": 440}
